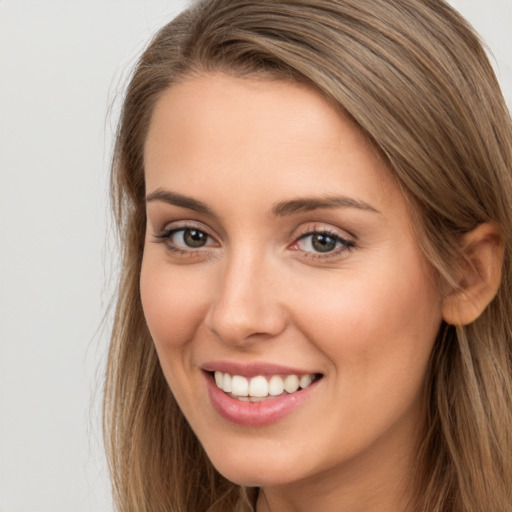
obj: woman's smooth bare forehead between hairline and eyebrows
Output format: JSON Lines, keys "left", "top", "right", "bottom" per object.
{"left": 145, "top": 74, "right": 401, "bottom": 218}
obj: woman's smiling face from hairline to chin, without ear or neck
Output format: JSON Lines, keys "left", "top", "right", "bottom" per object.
{"left": 141, "top": 74, "right": 441, "bottom": 496}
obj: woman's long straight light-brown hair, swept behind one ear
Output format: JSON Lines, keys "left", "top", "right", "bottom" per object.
{"left": 104, "top": 0, "right": 512, "bottom": 512}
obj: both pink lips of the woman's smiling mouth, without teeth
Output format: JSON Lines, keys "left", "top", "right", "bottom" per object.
{"left": 202, "top": 362, "right": 319, "bottom": 427}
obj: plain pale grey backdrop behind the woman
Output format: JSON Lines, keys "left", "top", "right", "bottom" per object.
{"left": 0, "top": 0, "right": 512, "bottom": 512}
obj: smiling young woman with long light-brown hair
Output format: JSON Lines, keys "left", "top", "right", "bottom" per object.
{"left": 105, "top": 0, "right": 512, "bottom": 512}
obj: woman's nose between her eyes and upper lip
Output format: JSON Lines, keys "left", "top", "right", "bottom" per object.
{"left": 205, "top": 250, "right": 287, "bottom": 345}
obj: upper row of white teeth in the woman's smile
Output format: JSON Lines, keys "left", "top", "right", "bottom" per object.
{"left": 215, "top": 372, "right": 314, "bottom": 398}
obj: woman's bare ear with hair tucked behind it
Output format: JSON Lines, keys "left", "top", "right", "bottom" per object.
{"left": 442, "top": 222, "right": 504, "bottom": 325}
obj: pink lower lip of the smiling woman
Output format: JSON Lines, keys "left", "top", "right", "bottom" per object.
{"left": 204, "top": 373, "right": 319, "bottom": 427}
